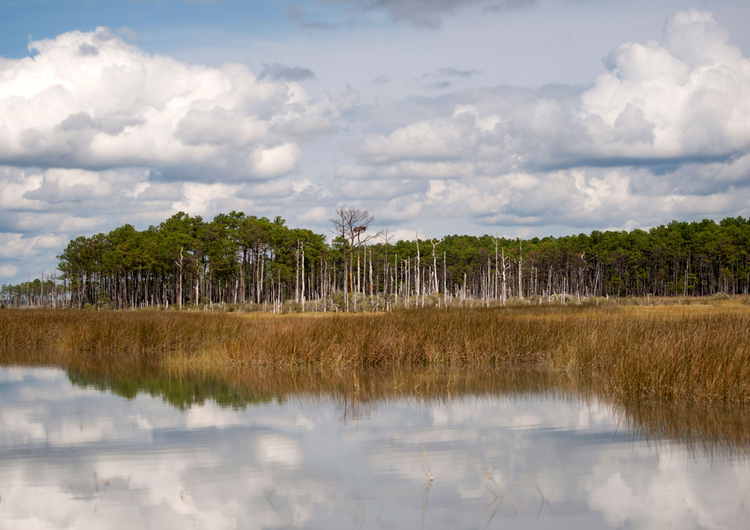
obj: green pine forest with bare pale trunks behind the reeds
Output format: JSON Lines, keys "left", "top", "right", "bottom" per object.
{"left": 0, "top": 208, "right": 750, "bottom": 312}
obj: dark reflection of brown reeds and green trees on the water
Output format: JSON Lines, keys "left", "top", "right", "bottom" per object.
{"left": 67, "top": 367, "right": 750, "bottom": 455}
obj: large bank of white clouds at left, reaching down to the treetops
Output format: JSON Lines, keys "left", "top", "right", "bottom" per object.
{"left": 0, "top": 28, "right": 358, "bottom": 281}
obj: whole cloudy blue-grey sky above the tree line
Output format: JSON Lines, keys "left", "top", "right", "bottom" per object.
{"left": 0, "top": 0, "right": 750, "bottom": 283}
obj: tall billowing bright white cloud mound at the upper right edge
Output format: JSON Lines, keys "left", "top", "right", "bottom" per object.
{"left": 581, "top": 9, "right": 750, "bottom": 158}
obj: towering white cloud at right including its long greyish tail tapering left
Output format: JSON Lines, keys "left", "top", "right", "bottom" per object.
{"left": 358, "top": 10, "right": 750, "bottom": 168}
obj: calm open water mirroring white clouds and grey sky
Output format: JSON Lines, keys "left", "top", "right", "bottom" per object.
{"left": 0, "top": 368, "right": 750, "bottom": 529}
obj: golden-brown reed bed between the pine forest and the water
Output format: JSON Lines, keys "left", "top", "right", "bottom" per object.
{"left": 0, "top": 304, "right": 750, "bottom": 403}
